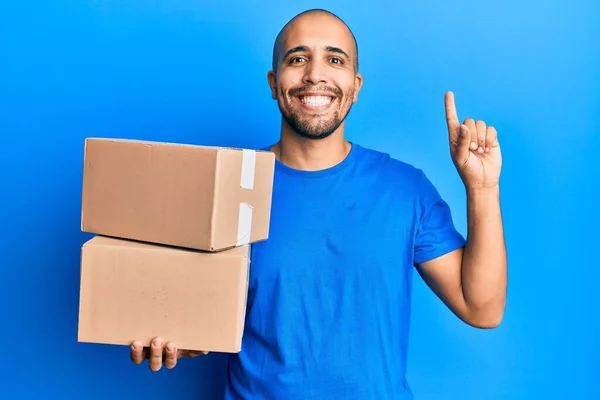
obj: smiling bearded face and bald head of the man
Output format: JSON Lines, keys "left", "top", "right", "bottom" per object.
{"left": 269, "top": 13, "right": 362, "bottom": 139}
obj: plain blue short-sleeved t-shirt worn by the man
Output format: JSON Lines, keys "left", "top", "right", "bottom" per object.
{"left": 225, "top": 144, "right": 465, "bottom": 400}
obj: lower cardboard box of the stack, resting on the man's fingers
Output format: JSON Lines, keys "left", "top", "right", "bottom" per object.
{"left": 78, "top": 236, "right": 250, "bottom": 353}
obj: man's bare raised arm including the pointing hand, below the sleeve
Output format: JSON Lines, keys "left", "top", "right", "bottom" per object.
{"left": 416, "top": 92, "right": 507, "bottom": 328}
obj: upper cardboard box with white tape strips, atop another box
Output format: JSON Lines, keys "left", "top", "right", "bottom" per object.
{"left": 81, "top": 138, "right": 275, "bottom": 251}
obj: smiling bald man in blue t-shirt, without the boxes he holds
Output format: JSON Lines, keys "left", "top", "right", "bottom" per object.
{"left": 131, "top": 10, "right": 507, "bottom": 400}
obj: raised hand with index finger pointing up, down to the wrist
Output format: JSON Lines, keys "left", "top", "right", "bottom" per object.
{"left": 445, "top": 92, "right": 502, "bottom": 189}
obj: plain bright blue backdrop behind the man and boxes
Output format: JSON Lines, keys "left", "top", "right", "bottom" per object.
{"left": 0, "top": 0, "right": 600, "bottom": 399}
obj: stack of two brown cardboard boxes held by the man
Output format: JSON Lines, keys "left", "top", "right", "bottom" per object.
{"left": 78, "top": 138, "right": 275, "bottom": 353}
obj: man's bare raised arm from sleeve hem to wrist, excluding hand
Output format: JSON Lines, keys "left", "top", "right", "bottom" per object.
{"left": 417, "top": 187, "right": 507, "bottom": 328}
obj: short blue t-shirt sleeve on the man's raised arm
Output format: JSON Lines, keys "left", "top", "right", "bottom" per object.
{"left": 414, "top": 172, "right": 466, "bottom": 264}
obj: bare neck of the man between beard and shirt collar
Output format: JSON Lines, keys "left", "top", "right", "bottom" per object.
{"left": 271, "top": 121, "right": 351, "bottom": 171}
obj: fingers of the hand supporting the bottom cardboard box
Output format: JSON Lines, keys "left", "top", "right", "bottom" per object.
{"left": 130, "top": 338, "right": 208, "bottom": 372}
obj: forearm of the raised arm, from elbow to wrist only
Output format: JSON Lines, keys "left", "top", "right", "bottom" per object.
{"left": 461, "top": 187, "right": 507, "bottom": 326}
